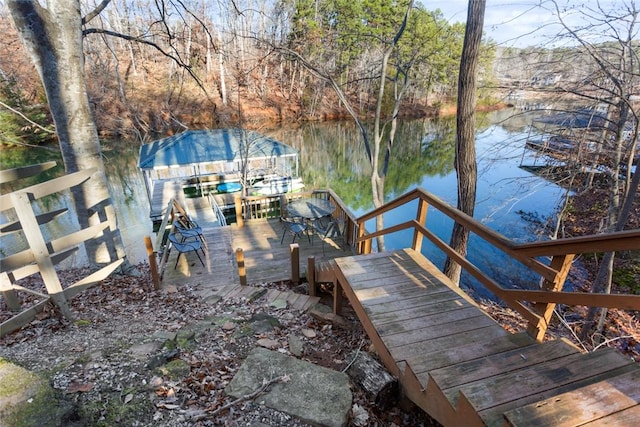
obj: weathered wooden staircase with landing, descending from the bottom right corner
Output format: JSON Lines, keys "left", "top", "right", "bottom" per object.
{"left": 326, "top": 249, "right": 640, "bottom": 426}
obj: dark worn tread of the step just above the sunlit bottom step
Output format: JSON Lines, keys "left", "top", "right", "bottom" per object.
{"left": 452, "top": 349, "right": 632, "bottom": 412}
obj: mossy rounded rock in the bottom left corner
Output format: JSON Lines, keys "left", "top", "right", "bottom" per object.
{"left": 0, "top": 358, "right": 71, "bottom": 427}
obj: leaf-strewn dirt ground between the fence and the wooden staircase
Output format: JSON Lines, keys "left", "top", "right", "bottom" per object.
{"left": 0, "top": 265, "right": 437, "bottom": 427}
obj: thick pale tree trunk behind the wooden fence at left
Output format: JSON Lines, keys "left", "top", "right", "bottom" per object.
{"left": 7, "top": 0, "right": 124, "bottom": 265}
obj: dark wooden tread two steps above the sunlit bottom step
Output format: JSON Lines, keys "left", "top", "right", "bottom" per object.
{"left": 429, "top": 340, "right": 579, "bottom": 390}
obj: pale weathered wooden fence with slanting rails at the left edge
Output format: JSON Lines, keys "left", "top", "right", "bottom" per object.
{"left": 0, "top": 162, "right": 123, "bottom": 336}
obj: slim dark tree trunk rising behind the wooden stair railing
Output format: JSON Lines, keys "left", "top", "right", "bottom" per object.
{"left": 444, "top": 0, "right": 486, "bottom": 284}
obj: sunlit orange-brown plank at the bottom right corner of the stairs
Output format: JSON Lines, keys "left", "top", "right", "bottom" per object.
{"left": 504, "top": 369, "right": 640, "bottom": 427}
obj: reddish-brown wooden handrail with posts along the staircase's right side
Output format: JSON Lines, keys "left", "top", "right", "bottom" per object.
{"left": 354, "top": 189, "right": 640, "bottom": 340}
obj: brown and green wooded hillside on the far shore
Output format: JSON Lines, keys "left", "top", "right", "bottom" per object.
{"left": 0, "top": 0, "right": 480, "bottom": 143}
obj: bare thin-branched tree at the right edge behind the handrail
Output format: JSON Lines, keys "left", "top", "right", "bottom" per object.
{"left": 552, "top": 0, "right": 640, "bottom": 339}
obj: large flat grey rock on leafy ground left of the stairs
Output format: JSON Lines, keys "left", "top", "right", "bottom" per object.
{"left": 225, "top": 348, "right": 352, "bottom": 427}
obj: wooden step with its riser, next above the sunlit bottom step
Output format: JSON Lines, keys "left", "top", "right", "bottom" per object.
{"left": 452, "top": 349, "right": 637, "bottom": 426}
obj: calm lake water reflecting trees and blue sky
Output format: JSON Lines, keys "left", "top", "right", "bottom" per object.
{"left": 0, "top": 110, "right": 564, "bottom": 296}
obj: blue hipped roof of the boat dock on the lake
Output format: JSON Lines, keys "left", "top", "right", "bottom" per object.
{"left": 138, "top": 128, "right": 298, "bottom": 169}
